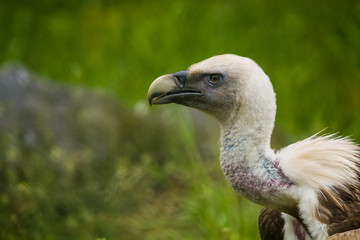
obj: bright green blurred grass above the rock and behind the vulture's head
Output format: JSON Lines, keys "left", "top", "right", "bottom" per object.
{"left": 0, "top": 0, "right": 360, "bottom": 138}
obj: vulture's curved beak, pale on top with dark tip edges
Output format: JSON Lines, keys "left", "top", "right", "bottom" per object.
{"left": 148, "top": 71, "right": 202, "bottom": 106}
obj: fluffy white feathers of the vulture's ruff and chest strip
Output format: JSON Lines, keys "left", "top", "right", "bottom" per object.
{"left": 277, "top": 134, "right": 360, "bottom": 239}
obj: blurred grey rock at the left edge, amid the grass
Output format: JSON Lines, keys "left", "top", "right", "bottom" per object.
{"left": 0, "top": 64, "right": 124, "bottom": 164}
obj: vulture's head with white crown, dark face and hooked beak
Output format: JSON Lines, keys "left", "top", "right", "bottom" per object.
{"left": 148, "top": 54, "right": 276, "bottom": 128}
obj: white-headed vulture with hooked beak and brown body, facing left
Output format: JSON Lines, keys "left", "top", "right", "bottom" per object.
{"left": 148, "top": 54, "right": 360, "bottom": 240}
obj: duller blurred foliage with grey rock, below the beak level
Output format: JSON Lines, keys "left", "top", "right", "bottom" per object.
{"left": 0, "top": 64, "right": 259, "bottom": 240}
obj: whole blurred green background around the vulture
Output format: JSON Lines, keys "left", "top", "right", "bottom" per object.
{"left": 0, "top": 0, "right": 360, "bottom": 240}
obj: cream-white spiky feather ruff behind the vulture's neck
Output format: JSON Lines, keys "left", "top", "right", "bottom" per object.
{"left": 277, "top": 134, "right": 360, "bottom": 191}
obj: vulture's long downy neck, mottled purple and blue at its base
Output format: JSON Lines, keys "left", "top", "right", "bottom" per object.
{"left": 220, "top": 107, "right": 292, "bottom": 210}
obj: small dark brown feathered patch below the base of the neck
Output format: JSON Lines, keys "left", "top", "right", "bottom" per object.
{"left": 259, "top": 207, "right": 284, "bottom": 240}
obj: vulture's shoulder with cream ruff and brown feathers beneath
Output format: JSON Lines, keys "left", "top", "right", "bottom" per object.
{"left": 277, "top": 134, "right": 360, "bottom": 235}
